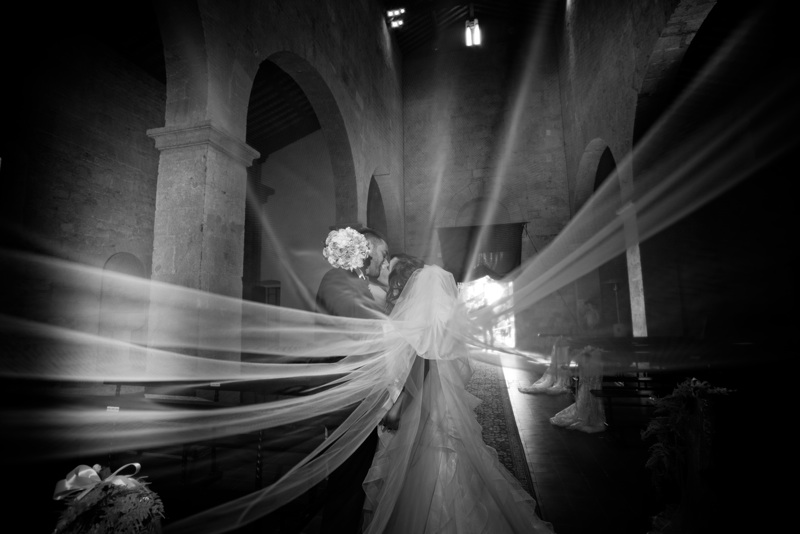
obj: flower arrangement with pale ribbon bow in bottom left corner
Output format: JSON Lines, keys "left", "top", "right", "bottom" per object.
{"left": 53, "top": 463, "right": 164, "bottom": 534}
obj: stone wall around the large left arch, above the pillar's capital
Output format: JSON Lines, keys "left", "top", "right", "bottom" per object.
{"left": 184, "top": 0, "right": 402, "bottom": 225}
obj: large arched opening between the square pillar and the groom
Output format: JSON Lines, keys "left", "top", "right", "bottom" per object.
{"left": 243, "top": 52, "right": 357, "bottom": 310}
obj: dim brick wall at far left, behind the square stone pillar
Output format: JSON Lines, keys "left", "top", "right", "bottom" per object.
{"left": 3, "top": 37, "right": 165, "bottom": 331}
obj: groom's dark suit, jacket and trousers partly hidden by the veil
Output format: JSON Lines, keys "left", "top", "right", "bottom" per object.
{"left": 317, "top": 268, "right": 383, "bottom": 534}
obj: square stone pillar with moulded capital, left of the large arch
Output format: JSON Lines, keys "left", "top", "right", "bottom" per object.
{"left": 147, "top": 121, "right": 258, "bottom": 371}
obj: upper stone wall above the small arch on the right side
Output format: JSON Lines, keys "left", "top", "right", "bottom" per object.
{"left": 558, "top": 0, "right": 679, "bottom": 209}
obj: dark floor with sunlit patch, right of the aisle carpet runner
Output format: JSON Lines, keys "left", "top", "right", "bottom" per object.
{"left": 505, "top": 368, "right": 660, "bottom": 534}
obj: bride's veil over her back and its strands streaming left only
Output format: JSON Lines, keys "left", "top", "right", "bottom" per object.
{"left": 0, "top": 246, "right": 524, "bottom": 532}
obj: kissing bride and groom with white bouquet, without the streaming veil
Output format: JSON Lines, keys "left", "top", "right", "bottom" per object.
{"left": 316, "top": 228, "right": 553, "bottom": 534}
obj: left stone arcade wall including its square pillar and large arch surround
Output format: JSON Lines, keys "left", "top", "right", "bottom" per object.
{"left": 143, "top": 1, "right": 402, "bottom": 312}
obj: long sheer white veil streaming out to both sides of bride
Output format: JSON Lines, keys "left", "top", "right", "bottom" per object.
{"left": 0, "top": 30, "right": 798, "bottom": 532}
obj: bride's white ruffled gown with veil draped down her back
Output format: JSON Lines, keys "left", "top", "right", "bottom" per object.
{"left": 363, "top": 266, "right": 553, "bottom": 534}
